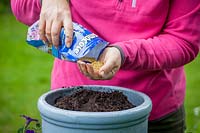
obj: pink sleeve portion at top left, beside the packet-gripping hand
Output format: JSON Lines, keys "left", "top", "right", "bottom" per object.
{"left": 11, "top": 0, "right": 41, "bottom": 26}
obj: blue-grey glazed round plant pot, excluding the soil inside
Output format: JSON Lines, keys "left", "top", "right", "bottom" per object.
{"left": 38, "top": 85, "right": 152, "bottom": 133}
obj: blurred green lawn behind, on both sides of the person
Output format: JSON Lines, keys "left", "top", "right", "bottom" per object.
{"left": 0, "top": 13, "right": 200, "bottom": 133}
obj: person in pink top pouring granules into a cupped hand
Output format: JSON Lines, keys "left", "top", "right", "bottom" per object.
{"left": 11, "top": 0, "right": 200, "bottom": 133}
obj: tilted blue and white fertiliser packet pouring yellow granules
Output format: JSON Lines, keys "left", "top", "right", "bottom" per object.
{"left": 26, "top": 21, "right": 109, "bottom": 62}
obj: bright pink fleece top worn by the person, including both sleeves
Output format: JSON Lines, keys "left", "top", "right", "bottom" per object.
{"left": 11, "top": 0, "right": 200, "bottom": 120}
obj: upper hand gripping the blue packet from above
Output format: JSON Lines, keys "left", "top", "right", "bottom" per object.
{"left": 39, "top": 0, "right": 73, "bottom": 48}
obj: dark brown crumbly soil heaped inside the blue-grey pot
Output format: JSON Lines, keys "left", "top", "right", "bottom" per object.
{"left": 54, "top": 90, "right": 135, "bottom": 112}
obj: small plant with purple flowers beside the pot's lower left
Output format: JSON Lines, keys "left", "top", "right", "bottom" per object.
{"left": 17, "top": 115, "right": 42, "bottom": 133}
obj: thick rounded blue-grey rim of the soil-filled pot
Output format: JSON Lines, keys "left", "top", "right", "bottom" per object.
{"left": 38, "top": 85, "right": 152, "bottom": 124}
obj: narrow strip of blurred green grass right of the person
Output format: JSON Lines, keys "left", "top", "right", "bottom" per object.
{"left": 185, "top": 54, "right": 200, "bottom": 133}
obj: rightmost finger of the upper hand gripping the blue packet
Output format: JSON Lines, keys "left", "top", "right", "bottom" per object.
{"left": 63, "top": 20, "right": 73, "bottom": 47}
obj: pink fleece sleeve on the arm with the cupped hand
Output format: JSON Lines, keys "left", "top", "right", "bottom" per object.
{"left": 112, "top": 0, "right": 200, "bottom": 70}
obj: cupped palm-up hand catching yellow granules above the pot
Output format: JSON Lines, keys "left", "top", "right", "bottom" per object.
{"left": 77, "top": 47, "right": 122, "bottom": 80}
